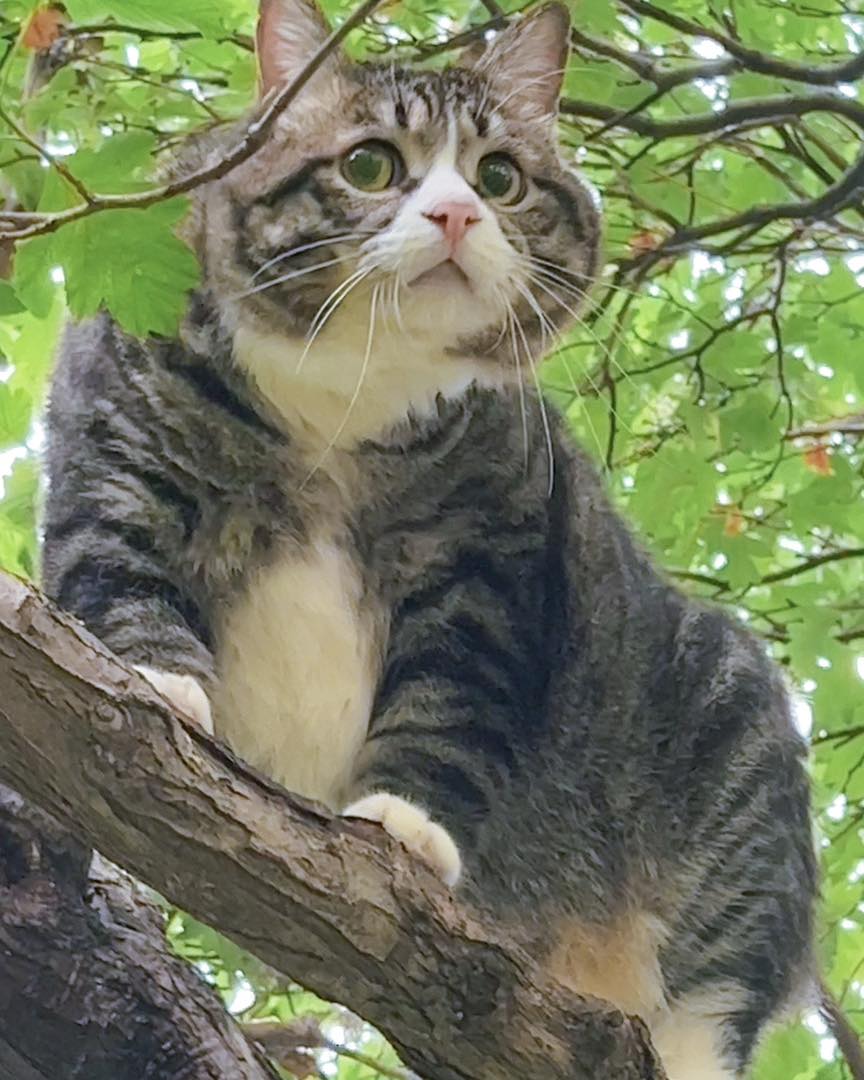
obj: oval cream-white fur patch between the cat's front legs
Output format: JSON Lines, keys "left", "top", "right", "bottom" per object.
{"left": 214, "top": 540, "right": 378, "bottom": 810}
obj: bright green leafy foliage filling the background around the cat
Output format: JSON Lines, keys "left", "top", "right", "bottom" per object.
{"left": 0, "top": 0, "right": 864, "bottom": 1080}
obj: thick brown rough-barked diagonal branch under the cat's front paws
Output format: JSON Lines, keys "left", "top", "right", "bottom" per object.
{"left": 0, "top": 577, "right": 662, "bottom": 1080}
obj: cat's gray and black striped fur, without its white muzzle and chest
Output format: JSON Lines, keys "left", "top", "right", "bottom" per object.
{"left": 43, "top": 0, "right": 815, "bottom": 1080}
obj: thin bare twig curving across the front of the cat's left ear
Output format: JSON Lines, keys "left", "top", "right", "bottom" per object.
{"left": 0, "top": 0, "right": 382, "bottom": 241}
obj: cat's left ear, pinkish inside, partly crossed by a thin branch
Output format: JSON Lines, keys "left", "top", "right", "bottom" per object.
{"left": 255, "top": 0, "right": 340, "bottom": 96}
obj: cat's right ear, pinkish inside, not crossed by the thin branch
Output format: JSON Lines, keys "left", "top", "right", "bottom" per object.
{"left": 461, "top": 3, "right": 570, "bottom": 121}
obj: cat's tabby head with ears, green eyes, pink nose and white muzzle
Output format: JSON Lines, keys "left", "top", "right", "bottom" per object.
{"left": 198, "top": 0, "right": 599, "bottom": 401}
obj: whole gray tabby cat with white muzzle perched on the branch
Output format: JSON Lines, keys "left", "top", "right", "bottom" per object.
{"left": 43, "top": 0, "right": 816, "bottom": 1080}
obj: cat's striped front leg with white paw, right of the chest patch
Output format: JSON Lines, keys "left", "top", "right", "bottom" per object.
{"left": 343, "top": 552, "right": 533, "bottom": 886}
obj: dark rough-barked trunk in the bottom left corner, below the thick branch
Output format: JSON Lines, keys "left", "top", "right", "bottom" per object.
{"left": 0, "top": 785, "right": 276, "bottom": 1080}
